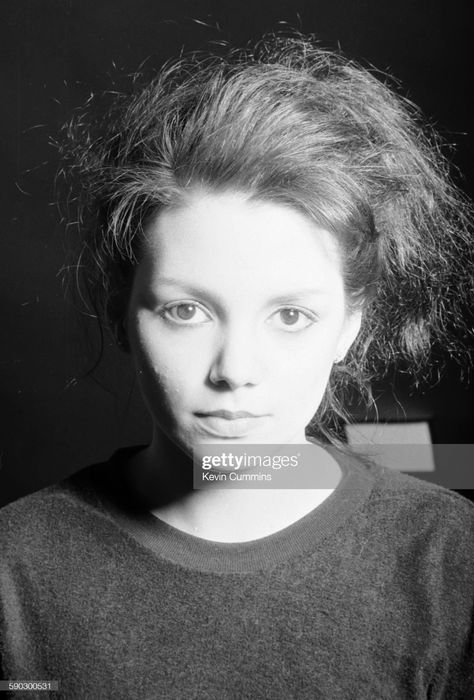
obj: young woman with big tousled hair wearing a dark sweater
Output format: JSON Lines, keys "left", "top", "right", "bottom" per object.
{"left": 0, "top": 37, "right": 474, "bottom": 700}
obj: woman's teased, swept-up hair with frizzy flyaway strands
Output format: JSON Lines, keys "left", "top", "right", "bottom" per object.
{"left": 57, "top": 34, "right": 472, "bottom": 440}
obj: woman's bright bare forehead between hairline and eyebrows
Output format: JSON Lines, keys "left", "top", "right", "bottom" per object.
{"left": 138, "top": 193, "right": 343, "bottom": 294}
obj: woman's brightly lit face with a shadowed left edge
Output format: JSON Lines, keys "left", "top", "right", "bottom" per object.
{"left": 128, "top": 193, "right": 360, "bottom": 453}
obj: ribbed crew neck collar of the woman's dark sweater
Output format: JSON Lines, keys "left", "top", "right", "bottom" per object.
{"left": 76, "top": 446, "right": 374, "bottom": 573}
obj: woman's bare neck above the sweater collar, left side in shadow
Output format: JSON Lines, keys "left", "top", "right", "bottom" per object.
{"left": 125, "top": 433, "right": 341, "bottom": 542}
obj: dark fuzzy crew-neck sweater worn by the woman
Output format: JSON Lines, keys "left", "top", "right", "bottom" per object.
{"left": 0, "top": 451, "right": 474, "bottom": 700}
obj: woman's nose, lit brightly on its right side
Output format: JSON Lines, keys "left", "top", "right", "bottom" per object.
{"left": 209, "top": 329, "right": 262, "bottom": 390}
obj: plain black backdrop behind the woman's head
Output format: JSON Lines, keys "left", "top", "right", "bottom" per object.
{"left": 0, "top": 0, "right": 474, "bottom": 503}
